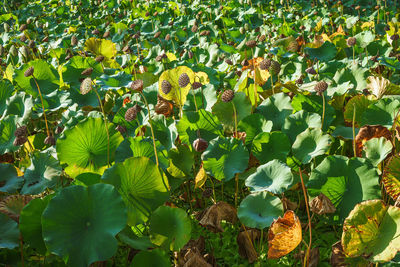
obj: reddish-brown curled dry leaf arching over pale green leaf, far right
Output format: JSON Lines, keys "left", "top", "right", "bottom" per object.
{"left": 356, "top": 125, "right": 392, "bottom": 157}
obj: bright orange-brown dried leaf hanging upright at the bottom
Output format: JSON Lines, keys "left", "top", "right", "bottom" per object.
{"left": 268, "top": 210, "right": 302, "bottom": 259}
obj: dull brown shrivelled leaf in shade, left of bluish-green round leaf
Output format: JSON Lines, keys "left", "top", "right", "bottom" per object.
{"left": 199, "top": 201, "right": 237, "bottom": 233}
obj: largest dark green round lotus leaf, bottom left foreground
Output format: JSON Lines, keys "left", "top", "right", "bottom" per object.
{"left": 42, "top": 184, "right": 127, "bottom": 266}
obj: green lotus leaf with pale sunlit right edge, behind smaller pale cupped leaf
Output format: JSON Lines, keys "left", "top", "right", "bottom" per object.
{"left": 282, "top": 110, "right": 322, "bottom": 143}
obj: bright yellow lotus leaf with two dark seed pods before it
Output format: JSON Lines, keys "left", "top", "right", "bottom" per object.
{"left": 158, "top": 66, "right": 195, "bottom": 106}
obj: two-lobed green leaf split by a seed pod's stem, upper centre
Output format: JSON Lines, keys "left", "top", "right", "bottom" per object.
{"left": 212, "top": 92, "right": 251, "bottom": 131}
